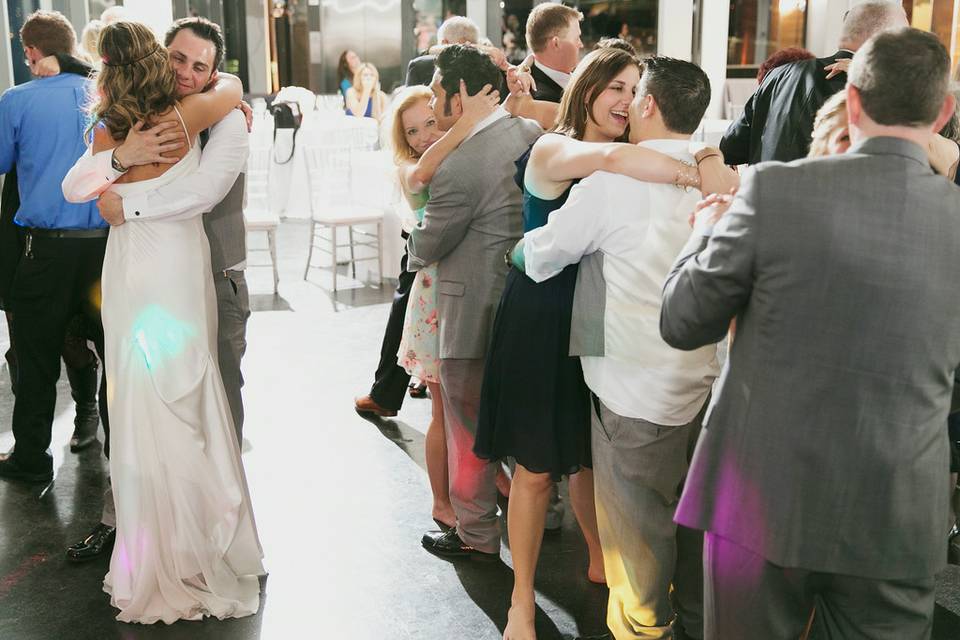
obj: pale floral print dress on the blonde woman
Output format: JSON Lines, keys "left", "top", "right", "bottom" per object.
{"left": 397, "top": 209, "right": 440, "bottom": 383}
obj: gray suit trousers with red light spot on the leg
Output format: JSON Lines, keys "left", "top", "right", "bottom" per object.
{"left": 440, "top": 359, "right": 500, "bottom": 553}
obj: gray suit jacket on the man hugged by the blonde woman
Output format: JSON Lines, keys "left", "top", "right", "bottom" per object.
{"left": 407, "top": 117, "right": 541, "bottom": 359}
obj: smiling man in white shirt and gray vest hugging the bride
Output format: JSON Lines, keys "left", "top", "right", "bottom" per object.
{"left": 63, "top": 18, "right": 250, "bottom": 561}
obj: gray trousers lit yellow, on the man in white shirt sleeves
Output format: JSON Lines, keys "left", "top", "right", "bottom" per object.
{"left": 591, "top": 401, "right": 704, "bottom": 640}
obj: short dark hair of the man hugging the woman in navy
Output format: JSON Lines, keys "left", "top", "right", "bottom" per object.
{"left": 637, "top": 56, "right": 710, "bottom": 134}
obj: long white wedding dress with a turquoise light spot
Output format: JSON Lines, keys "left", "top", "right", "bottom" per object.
{"left": 101, "top": 112, "right": 264, "bottom": 624}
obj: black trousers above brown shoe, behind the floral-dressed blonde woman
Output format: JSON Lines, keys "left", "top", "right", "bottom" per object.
{"left": 370, "top": 238, "right": 417, "bottom": 411}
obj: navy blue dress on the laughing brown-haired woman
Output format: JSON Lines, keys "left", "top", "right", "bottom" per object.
{"left": 474, "top": 142, "right": 591, "bottom": 479}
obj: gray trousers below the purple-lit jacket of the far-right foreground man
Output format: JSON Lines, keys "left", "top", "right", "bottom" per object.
{"left": 703, "top": 533, "right": 934, "bottom": 640}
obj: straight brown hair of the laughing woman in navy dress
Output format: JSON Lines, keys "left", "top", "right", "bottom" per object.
{"left": 553, "top": 47, "right": 641, "bottom": 140}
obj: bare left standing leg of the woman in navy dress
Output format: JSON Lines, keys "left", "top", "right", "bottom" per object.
{"left": 503, "top": 463, "right": 553, "bottom": 640}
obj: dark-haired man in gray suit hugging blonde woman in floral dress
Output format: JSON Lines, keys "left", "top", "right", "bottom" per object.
{"left": 407, "top": 45, "right": 541, "bottom": 560}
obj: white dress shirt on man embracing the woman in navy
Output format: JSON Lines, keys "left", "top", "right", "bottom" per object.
{"left": 524, "top": 140, "right": 720, "bottom": 426}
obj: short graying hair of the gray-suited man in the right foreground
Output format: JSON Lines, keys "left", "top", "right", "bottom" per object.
{"left": 847, "top": 27, "right": 950, "bottom": 127}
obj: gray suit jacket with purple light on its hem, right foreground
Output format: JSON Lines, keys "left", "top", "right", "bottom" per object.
{"left": 660, "top": 138, "right": 960, "bottom": 579}
